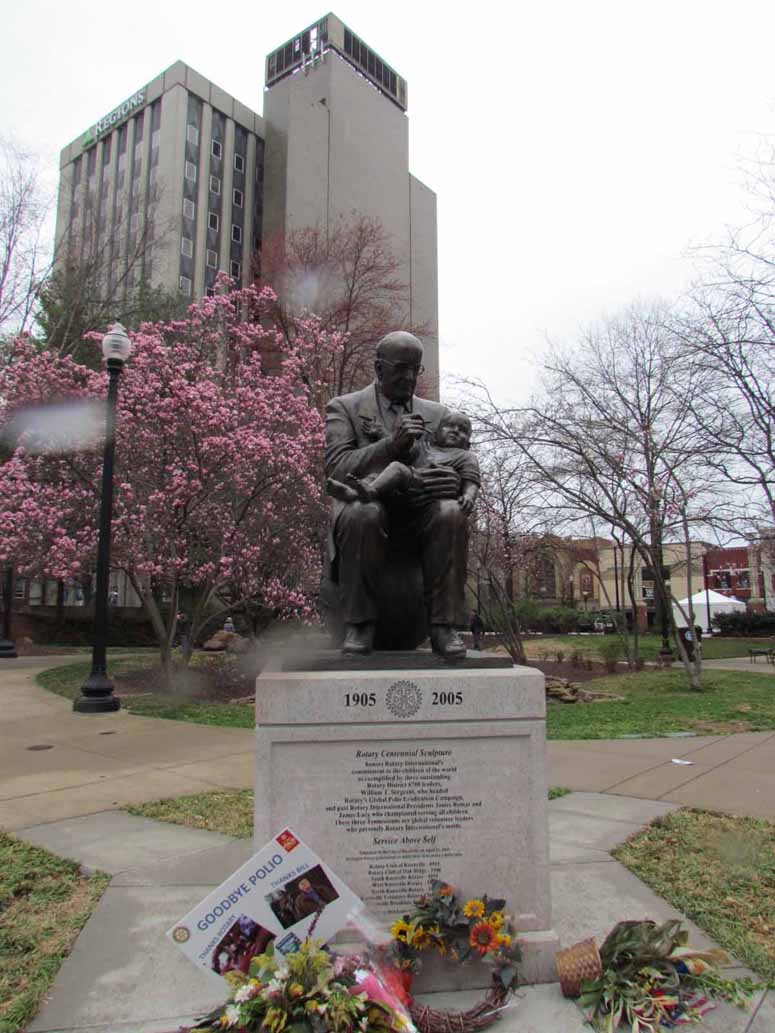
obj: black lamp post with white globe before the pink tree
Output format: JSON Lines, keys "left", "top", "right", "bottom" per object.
{"left": 72, "top": 323, "right": 132, "bottom": 714}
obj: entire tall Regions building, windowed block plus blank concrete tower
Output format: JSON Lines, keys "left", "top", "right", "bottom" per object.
{"left": 57, "top": 14, "right": 438, "bottom": 397}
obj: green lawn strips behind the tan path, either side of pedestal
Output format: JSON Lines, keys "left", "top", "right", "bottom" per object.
{"left": 38, "top": 654, "right": 775, "bottom": 739}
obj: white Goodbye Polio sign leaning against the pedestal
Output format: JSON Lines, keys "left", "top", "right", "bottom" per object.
{"left": 167, "top": 828, "right": 363, "bottom": 976}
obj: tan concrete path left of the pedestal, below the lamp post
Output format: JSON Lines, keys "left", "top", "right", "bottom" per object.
{"left": 0, "top": 656, "right": 254, "bottom": 829}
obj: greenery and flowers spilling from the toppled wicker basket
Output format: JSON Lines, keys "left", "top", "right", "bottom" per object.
{"left": 579, "top": 920, "right": 760, "bottom": 1033}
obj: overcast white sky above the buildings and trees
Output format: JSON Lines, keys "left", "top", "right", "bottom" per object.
{"left": 0, "top": 0, "right": 775, "bottom": 398}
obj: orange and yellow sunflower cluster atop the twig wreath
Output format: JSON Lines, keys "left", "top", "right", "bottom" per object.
{"left": 391, "top": 881, "right": 521, "bottom": 994}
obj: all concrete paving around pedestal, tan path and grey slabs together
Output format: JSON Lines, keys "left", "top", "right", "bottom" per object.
{"left": 0, "top": 657, "right": 775, "bottom": 1033}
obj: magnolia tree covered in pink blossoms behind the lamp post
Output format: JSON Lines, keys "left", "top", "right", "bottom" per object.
{"left": 0, "top": 288, "right": 341, "bottom": 684}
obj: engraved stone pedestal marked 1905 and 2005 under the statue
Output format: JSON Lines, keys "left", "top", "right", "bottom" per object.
{"left": 254, "top": 654, "right": 558, "bottom": 993}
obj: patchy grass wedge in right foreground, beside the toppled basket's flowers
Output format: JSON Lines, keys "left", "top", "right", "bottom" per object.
{"left": 613, "top": 810, "right": 775, "bottom": 983}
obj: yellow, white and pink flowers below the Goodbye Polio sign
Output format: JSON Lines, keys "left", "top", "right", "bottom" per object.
{"left": 193, "top": 939, "right": 413, "bottom": 1033}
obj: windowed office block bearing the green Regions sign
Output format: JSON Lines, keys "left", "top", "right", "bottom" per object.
{"left": 56, "top": 61, "right": 264, "bottom": 300}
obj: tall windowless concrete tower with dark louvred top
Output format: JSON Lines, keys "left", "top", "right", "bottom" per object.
{"left": 264, "top": 14, "right": 438, "bottom": 398}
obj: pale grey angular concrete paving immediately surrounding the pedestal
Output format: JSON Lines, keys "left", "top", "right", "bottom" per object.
{"left": 20, "top": 793, "right": 775, "bottom": 1033}
